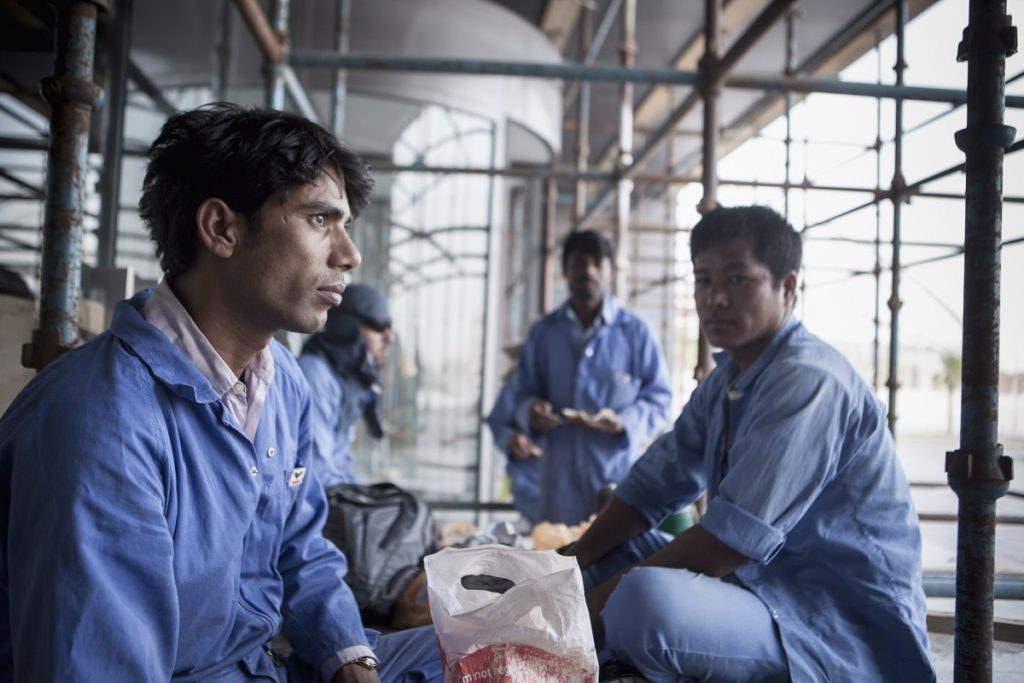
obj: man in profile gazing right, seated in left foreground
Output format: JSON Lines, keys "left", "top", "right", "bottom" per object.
{"left": 0, "top": 104, "right": 441, "bottom": 683}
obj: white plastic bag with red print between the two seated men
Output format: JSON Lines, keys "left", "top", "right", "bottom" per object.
{"left": 424, "top": 545, "right": 598, "bottom": 683}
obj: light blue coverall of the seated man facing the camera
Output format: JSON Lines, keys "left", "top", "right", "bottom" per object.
{"left": 588, "top": 316, "right": 935, "bottom": 683}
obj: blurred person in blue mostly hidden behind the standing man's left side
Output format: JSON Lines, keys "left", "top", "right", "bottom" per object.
{"left": 487, "top": 344, "right": 544, "bottom": 526}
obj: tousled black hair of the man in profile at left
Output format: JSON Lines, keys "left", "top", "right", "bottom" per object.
{"left": 139, "top": 102, "right": 374, "bottom": 278}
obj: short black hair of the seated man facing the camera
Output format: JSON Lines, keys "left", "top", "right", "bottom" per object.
{"left": 690, "top": 206, "right": 803, "bottom": 285}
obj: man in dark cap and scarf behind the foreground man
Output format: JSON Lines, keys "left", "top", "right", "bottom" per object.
{"left": 299, "top": 285, "right": 392, "bottom": 488}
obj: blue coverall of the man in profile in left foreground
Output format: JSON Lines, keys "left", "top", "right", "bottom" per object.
{"left": 0, "top": 292, "right": 439, "bottom": 683}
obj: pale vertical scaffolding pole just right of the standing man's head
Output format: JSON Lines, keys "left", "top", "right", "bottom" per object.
{"left": 612, "top": 0, "right": 637, "bottom": 297}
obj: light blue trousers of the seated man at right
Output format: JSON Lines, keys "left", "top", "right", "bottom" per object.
{"left": 584, "top": 531, "right": 790, "bottom": 683}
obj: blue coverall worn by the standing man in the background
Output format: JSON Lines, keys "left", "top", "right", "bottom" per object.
{"left": 516, "top": 294, "right": 672, "bottom": 524}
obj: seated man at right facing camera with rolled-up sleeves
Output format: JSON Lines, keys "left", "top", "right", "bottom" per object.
{"left": 565, "top": 207, "right": 935, "bottom": 682}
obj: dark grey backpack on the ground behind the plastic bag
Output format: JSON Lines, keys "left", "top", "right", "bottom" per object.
{"left": 324, "top": 483, "right": 438, "bottom": 625}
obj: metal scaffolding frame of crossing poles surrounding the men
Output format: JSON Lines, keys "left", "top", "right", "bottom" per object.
{"left": 0, "top": 0, "right": 1024, "bottom": 681}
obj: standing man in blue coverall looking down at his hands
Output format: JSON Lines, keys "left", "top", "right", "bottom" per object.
{"left": 516, "top": 230, "right": 672, "bottom": 524}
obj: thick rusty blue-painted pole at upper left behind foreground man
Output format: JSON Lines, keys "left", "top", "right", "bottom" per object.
{"left": 22, "top": 0, "right": 108, "bottom": 370}
